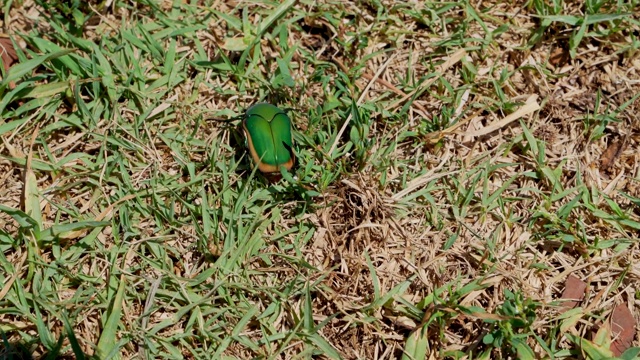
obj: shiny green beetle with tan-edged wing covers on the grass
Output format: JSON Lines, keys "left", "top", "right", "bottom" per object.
{"left": 242, "top": 103, "right": 295, "bottom": 178}
